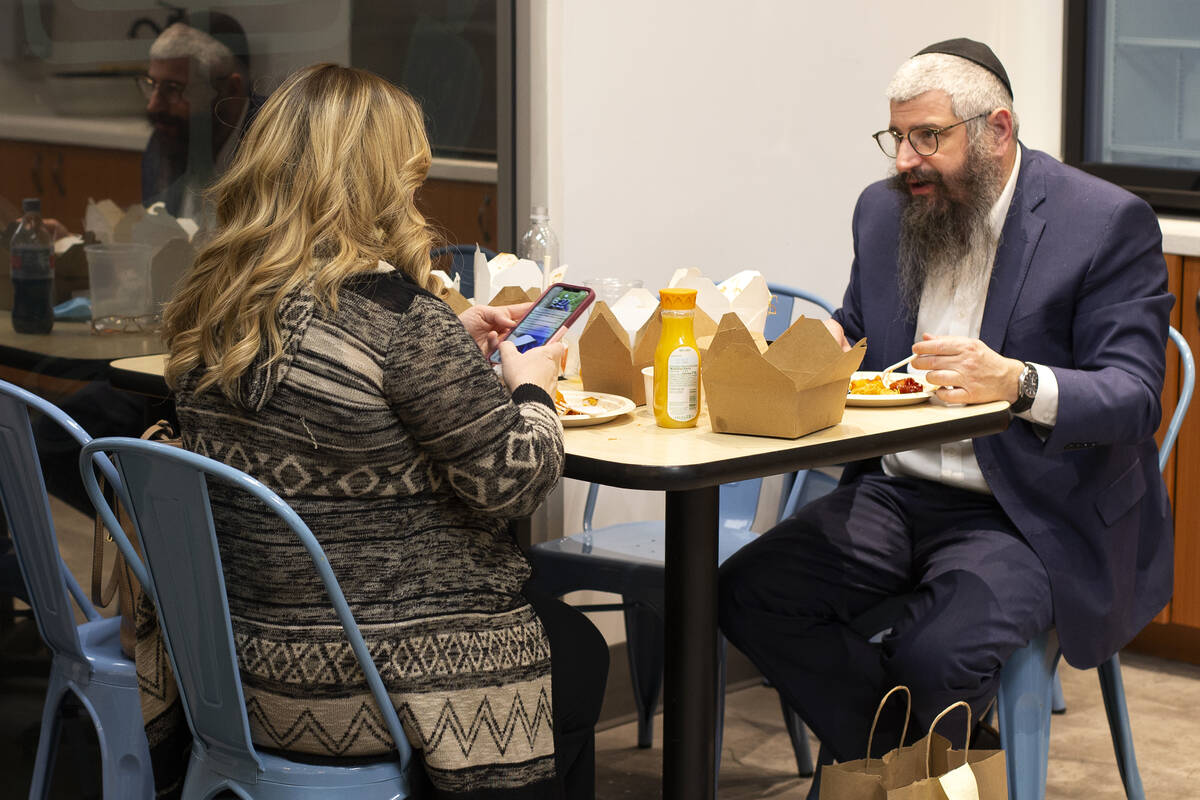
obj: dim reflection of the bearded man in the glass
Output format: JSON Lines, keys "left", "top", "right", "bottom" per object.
{"left": 139, "top": 12, "right": 262, "bottom": 222}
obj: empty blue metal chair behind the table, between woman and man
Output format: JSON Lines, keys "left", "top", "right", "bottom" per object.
{"left": 528, "top": 283, "right": 836, "bottom": 776}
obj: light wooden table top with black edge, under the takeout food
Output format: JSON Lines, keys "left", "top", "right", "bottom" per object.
{"left": 110, "top": 355, "right": 1009, "bottom": 489}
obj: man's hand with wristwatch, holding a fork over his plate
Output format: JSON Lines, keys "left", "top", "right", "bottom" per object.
{"left": 912, "top": 333, "right": 1025, "bottom": 403}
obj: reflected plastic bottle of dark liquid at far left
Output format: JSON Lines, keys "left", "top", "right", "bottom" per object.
{"left": 8, "top": 197, "right": 54, "bottom": 333}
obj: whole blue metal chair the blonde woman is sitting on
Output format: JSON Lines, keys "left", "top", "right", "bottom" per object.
{"left": 79, "top": 437, "right": 413, "bottom": 800}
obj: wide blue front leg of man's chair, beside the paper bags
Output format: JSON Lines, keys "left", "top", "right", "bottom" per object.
{"left": 996, "top": 631, "right": 1058, "bottom": 800}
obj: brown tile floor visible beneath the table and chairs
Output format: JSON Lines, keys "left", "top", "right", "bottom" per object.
{"left": 0, "top": 496, "right": 1200, "bottom": 800}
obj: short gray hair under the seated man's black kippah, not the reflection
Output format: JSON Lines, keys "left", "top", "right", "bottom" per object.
{"left": 888, "top": 53, "right": 1019, "bottom": 137}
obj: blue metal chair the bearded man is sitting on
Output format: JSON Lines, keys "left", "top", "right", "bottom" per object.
{"left": 996, "top": 327, "right": 1195, "bottom": 800}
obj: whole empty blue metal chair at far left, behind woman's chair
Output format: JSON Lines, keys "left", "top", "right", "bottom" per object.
{"left": 0, "top": 381, "right": 154, "bottom": 800}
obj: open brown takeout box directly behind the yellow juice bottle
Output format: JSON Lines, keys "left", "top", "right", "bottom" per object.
{"left": 580, "top": 300, "right": 716, "bottom": 405}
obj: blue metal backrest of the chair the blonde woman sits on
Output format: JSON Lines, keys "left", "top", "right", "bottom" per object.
{"left": 79, "top": 438, "right": 412, "bottom": 780}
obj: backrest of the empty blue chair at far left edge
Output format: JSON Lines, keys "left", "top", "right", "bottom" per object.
{"left": 0, "top": 380, "right": 115, "bottom": 681}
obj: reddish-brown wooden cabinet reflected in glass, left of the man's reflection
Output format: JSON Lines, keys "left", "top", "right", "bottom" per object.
{"left": 0, "top": 139, "right": 142, "bottom": 233}
